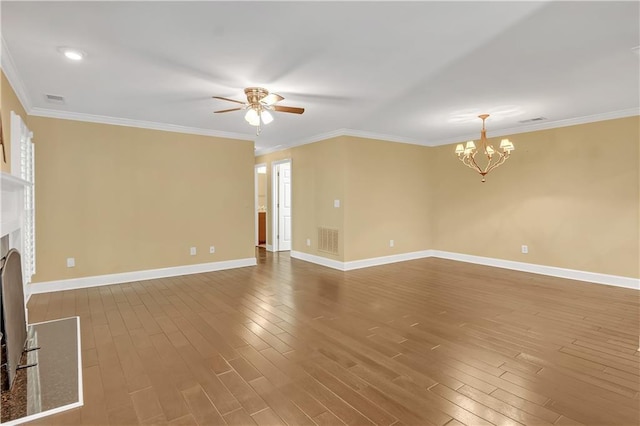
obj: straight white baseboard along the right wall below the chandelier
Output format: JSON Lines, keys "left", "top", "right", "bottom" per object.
{"left": 432, "top": 250, "right": 640, "bottom": 290}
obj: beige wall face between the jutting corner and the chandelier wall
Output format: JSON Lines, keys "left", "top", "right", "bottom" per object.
{"left": 344, "top": 137, "right": 432, "bottom": 261}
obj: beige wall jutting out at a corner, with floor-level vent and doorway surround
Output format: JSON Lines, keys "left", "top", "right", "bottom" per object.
{"left": 256, "top": 136, "right": 430, "bottom": 262}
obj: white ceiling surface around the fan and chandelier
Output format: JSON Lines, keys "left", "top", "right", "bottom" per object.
{"left": 1, "top": 1, "right": 640, "bottom": 152}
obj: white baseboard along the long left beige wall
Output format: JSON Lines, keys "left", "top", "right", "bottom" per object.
{"left": 29, "top": 257, "right": 257, "bottom": 296}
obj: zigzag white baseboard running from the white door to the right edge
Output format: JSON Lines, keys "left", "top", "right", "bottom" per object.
{"left": 291, "top": 250, "right": 640, "bottom": 290}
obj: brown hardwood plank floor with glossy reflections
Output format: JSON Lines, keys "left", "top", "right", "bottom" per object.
{"left": 29, "top": 250, "right": 640, "bottom": 426}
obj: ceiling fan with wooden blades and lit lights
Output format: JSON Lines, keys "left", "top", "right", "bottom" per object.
{"left": 213, "top": 87, "right": 304, "bottom": 135}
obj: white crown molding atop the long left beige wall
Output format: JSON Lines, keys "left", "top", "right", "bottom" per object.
{"left": 29, "top": 107, "right": 255, "bottom": 141}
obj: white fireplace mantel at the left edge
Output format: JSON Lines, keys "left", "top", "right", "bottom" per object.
{"left": 0, "top": 172, "right": 31, "bottom": 237}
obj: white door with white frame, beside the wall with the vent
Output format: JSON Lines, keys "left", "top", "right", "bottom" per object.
{"left": 271, "top": 160, "right": 291, "bottom": 251}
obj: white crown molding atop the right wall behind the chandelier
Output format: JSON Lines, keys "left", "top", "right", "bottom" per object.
{"left": 427, "top": 107, "right": 640, "bottom": 146}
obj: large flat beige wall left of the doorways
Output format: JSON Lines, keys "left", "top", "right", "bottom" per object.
{"left": 29, "top": 117, "right": 254, "bottom": 282}
